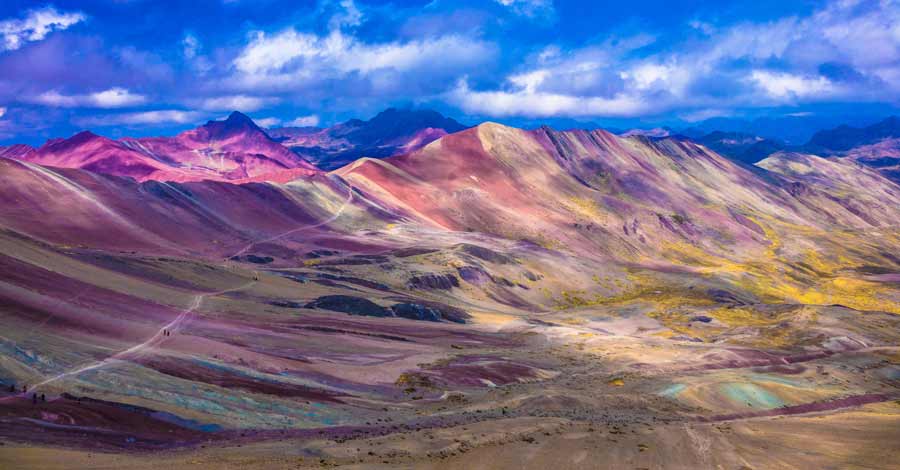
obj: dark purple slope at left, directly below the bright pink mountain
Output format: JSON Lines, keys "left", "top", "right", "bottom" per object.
{"left": 0, "top": 159, "right": 370, "bottom": 258}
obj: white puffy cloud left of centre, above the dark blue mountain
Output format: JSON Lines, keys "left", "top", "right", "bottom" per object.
{"left": 219, "top": 28, "right": 496, "bottom": 105}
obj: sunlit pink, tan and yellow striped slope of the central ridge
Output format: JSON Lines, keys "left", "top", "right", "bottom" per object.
{"left": 337, "top": 123, "right": 900, "bottom": 311}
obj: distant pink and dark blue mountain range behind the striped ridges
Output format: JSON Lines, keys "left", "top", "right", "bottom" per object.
{"left": 0, "top": 108, "right": 900, "bottom": 182}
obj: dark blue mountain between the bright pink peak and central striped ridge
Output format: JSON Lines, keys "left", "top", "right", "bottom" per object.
{"left": 269, "top": 108, "right": 466, "bottom": 170}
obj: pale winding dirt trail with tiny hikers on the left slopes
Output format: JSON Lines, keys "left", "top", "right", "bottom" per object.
{"left": 10, "top": 183, "right": 353, "bottom": 396}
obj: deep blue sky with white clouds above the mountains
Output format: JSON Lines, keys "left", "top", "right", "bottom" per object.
{"left": 0, "top": 0, "right": 900, "bottom": 143}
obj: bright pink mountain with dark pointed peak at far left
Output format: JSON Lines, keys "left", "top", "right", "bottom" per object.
{"left": 0, "top": 112, "right": 318, "bottom": 181}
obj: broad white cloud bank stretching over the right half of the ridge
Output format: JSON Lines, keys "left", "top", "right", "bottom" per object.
{"left": 454, "top": 0, "right": 900, "bottom": 119}
